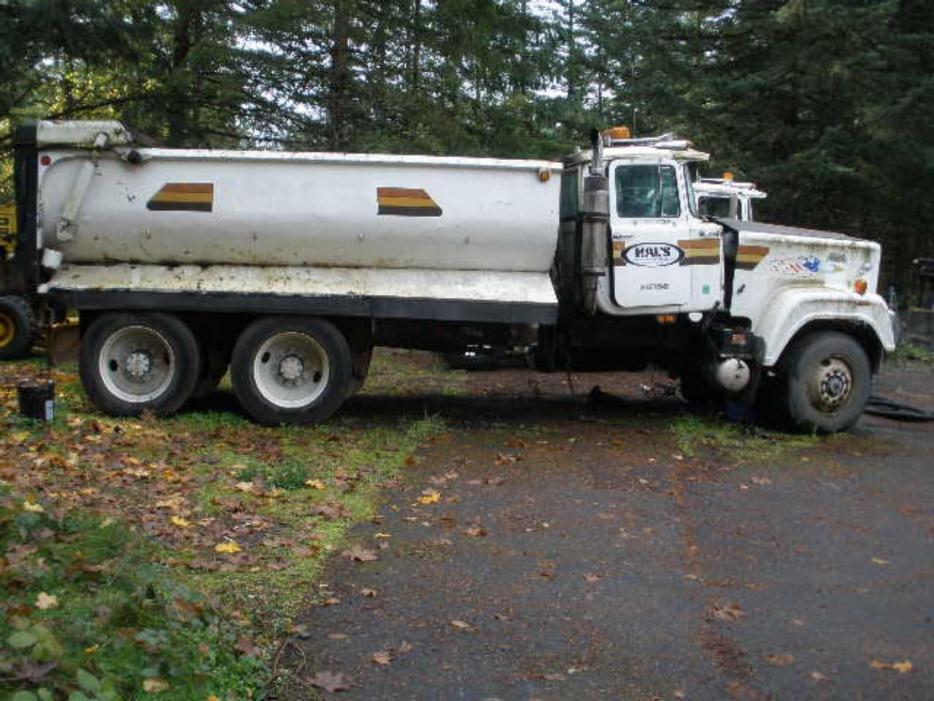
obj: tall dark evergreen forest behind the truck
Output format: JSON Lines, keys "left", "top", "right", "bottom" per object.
{"left": 0, "top": 0, "right": 934, "bottom": 293}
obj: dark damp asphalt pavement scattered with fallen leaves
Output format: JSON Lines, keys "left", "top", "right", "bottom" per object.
{"left": 281, "top": 360, "right": 934, "bottom": 701}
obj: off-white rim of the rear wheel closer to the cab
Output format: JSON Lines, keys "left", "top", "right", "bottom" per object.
{"left": 253, "top": 331, "right": 331, "bottom": 409}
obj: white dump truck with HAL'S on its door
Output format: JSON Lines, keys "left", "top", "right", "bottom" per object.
{"left": 0, "top": 121, "right": 894, "bottom": 431}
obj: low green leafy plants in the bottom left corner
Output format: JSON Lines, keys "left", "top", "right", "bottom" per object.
{"left": 0, "top": 495, "right": 264, "bottom": 701}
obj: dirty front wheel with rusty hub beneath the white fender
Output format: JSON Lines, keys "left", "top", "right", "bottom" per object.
{"left": 782, "top": 331, "right": 872, "bottom": 433}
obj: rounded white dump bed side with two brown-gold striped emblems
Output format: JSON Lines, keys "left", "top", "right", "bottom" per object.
{"left": 38, "top": 147, "right": 561, "bottom": 272}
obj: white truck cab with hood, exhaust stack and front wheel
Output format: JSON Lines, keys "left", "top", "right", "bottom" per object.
{"left": 555, "top": 128, "right": 894, "bottom": 431}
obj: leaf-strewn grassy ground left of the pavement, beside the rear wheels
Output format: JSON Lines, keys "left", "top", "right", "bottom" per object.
{"left": 0, "top": 353, "right": 454, "bottom": 701}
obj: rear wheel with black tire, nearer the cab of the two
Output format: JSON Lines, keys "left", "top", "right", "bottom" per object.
{"left": 230, "top": 317, "right": 353, "bottom": 425}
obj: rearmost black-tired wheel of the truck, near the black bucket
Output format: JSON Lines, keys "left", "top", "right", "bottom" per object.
{"left": 79, "top": 312, "right": 200, "bottom": 416}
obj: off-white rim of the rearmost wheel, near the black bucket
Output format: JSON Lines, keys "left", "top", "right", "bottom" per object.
{"left": 98, "top": 326, "right": 175, "bottom": 404}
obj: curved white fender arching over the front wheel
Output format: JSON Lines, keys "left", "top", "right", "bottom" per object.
{"left": 753, "top": 287, "right": 895, "bottom": 367}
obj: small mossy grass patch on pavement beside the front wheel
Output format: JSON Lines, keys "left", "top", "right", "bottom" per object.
{"left": 672, "top": 415, "right": 834, "bottom": 464}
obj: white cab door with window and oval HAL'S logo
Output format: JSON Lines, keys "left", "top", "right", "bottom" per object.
{"left": 609, "top": 160, "right": 722, "bottom": 314}
